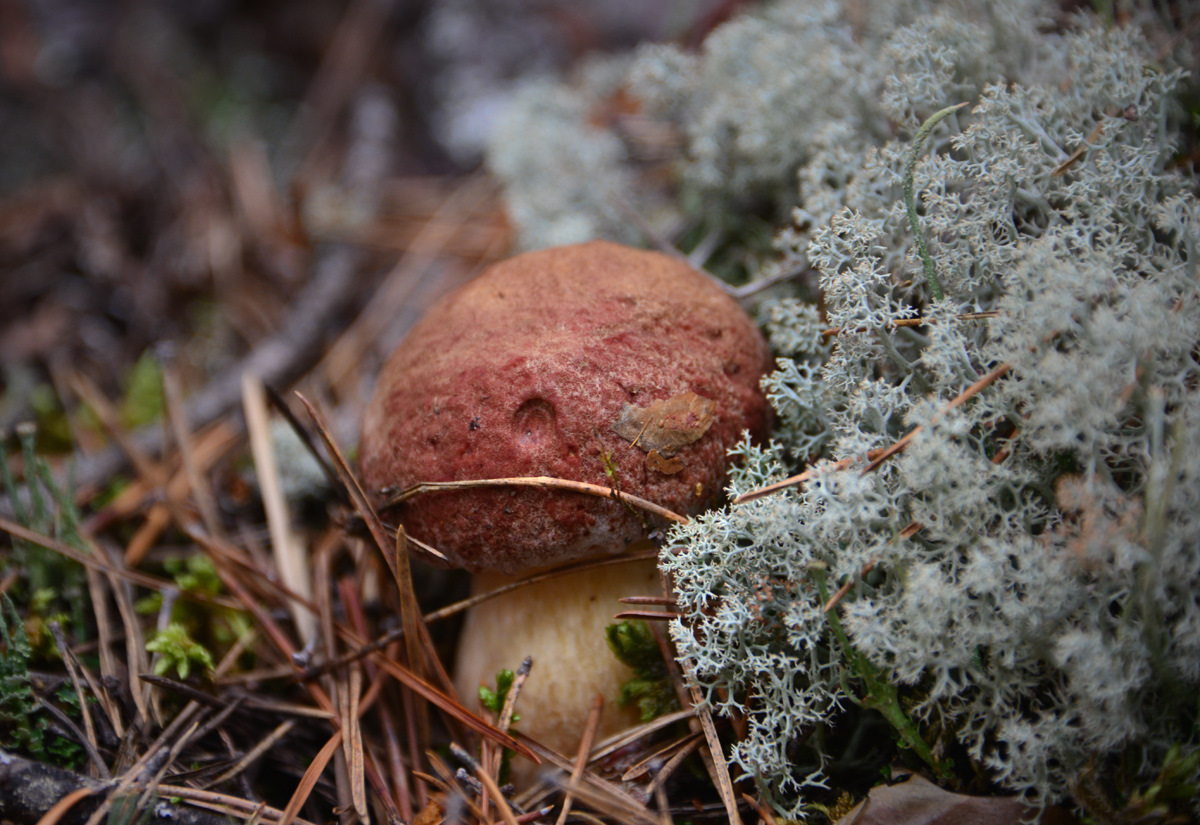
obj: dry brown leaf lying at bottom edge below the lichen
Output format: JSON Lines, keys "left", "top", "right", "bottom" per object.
{"left": 836, "top": 773, "right": 1078, "bottom": 825}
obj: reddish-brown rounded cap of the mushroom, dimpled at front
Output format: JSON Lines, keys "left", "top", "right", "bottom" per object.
{"left": 360, "top": 241, "right": 769, "bottom": 574}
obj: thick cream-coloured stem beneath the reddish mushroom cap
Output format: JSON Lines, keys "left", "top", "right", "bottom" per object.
{"left": 455, "top": 559, "right": 661, "bottom": 778}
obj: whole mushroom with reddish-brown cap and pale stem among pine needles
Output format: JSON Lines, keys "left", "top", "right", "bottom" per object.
{"left": 360, "top": 241, "right": 768, "bottom": 772}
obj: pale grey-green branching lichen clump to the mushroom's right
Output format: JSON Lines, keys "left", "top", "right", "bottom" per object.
{"left": 482, "top": 0, "right": 1200, "bottom": 815}
